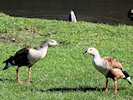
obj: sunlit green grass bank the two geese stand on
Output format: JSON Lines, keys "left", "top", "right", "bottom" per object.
{"left": 0, "top": 13, "right": 133, "bottom": 100}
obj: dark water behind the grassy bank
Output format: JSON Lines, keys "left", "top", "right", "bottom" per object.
{"left": 0, "top": 0, "right": 133, "bottom": 25}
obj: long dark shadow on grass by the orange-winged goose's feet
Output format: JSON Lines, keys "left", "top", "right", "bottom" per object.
{"left": 28, "top": 86, "right": 104, "bottom": 92}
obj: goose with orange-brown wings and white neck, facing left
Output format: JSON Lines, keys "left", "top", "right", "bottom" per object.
{"left": 84, "top": 47, "right": 132, "bottom": 94}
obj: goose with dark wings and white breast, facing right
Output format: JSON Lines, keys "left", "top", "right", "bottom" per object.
{"left": 3, "top": 40, "right": 58, "bottom": 84}
